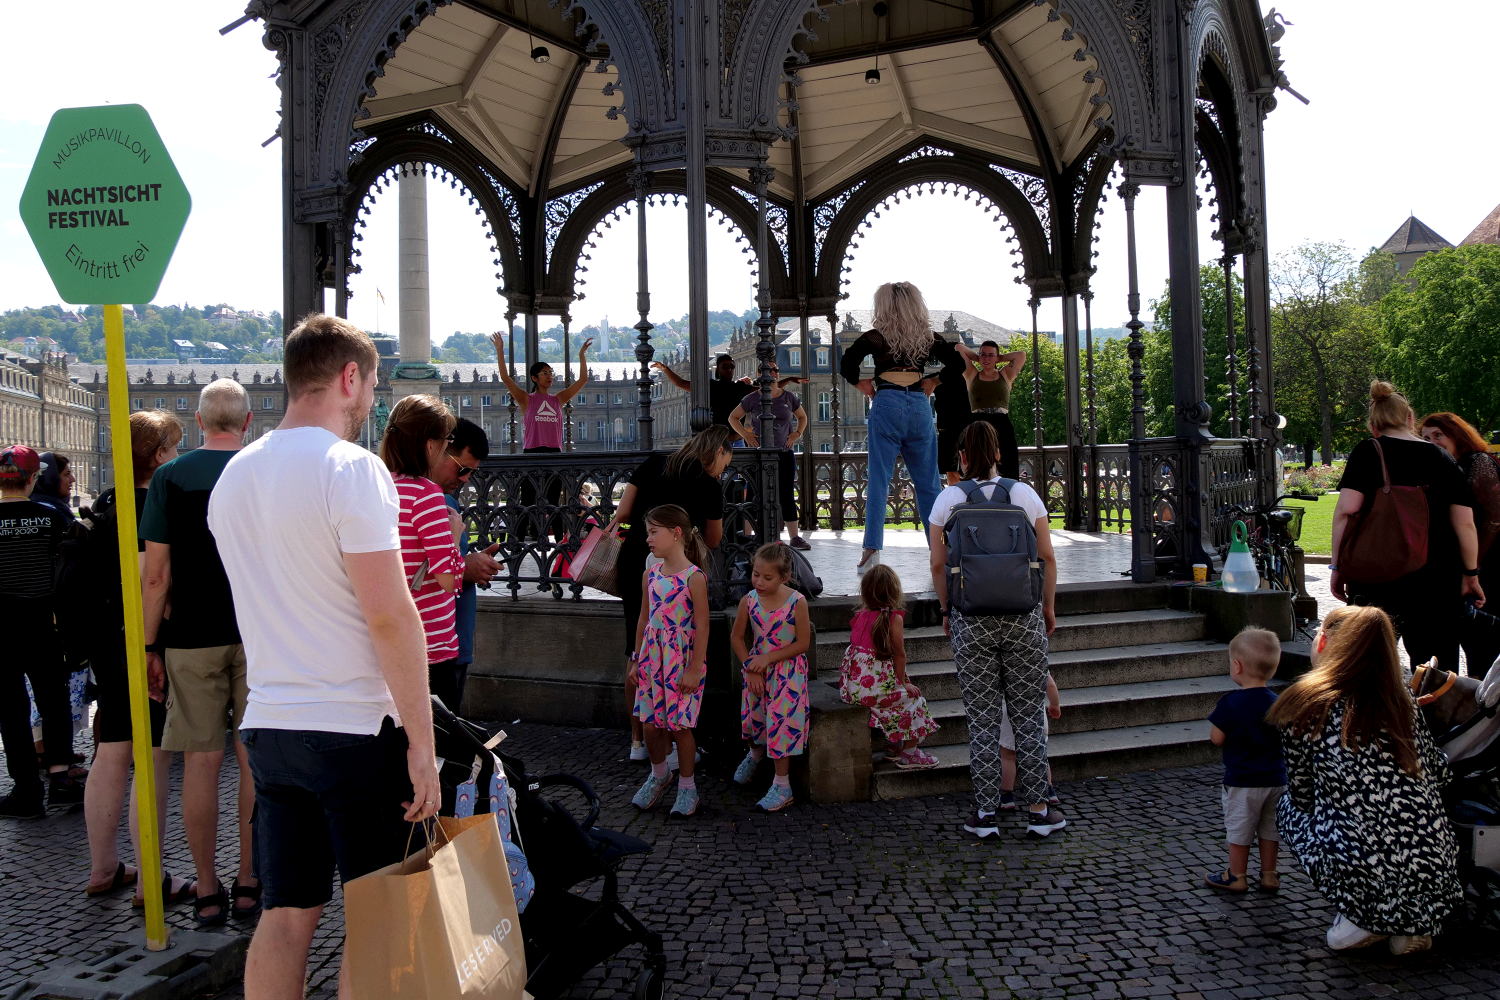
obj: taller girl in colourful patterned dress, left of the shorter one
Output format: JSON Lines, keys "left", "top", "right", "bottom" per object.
{"left": 632, "top": 504, "right": 708, "bottom": 816}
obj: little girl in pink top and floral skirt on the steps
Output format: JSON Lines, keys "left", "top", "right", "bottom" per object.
{"left": 839, "top": 565, "right": 938, "bottom": 771}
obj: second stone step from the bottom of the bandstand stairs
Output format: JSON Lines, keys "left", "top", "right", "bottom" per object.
{"left": 918, "top": 672, "right": 1235, "bottom": 747}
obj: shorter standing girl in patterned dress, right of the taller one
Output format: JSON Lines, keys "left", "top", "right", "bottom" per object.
{"left": 729, "top": 543, "right": 812, "bottom": 813}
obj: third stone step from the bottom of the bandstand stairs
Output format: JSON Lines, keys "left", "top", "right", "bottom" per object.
{"left": 876, "top": 639, "right": 1229, "bottom": 700}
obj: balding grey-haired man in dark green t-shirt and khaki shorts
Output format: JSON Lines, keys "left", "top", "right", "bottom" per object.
{"left": 141, "top": 378, "right": 261, "bottom": 927}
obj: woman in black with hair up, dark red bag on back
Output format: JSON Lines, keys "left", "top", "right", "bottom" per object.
{"left": 1329, "top": 381, "right": 1485, "bottom": 672}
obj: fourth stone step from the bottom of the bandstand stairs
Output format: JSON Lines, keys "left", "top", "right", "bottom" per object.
{"left": 816, "top": 607, "right": 1205, "bottom": 670}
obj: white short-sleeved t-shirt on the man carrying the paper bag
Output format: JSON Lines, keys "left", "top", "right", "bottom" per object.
{"left": 209, "top": 427, "right": 401, "bottom": 735}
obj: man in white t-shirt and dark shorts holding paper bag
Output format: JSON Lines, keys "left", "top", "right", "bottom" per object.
{"left": 209, "top": 313, "right": 443, "bottom": 1000}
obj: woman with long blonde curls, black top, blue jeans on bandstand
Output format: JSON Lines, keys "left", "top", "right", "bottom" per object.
{"left": 839, "top": 282, "right": 978, "bottom": 573}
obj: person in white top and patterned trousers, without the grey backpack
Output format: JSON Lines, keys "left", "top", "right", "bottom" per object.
{"left": 929, "top": 420, "right": 1068, "bottom": 838}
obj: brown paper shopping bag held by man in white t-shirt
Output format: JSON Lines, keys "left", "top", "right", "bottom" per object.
{"left": 344, "top": 813, "right": 527, "bottom": 1000}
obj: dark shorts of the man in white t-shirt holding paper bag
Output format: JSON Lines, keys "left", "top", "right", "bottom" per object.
{"left": 240, "top": 718, "right": 413, "bottom": 910}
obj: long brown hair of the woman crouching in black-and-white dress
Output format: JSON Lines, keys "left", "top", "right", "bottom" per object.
{"left": 1266, "top": 604, "right": 1422, "bottom": 777}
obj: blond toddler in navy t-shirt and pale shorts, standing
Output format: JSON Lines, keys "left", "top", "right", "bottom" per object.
{"left": 1203, "top": 628, "right": 1287, "bottom": 892}
